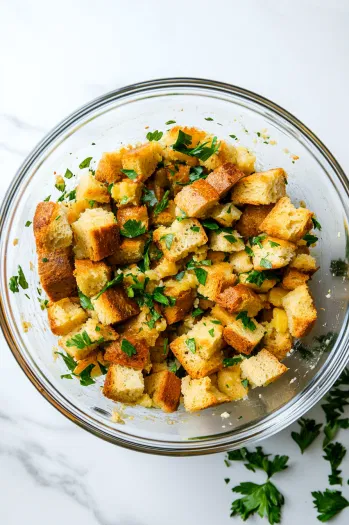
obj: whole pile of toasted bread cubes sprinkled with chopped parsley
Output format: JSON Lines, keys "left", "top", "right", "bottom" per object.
{"left": 33, "top": 126, "right": 318, "bottom": 412}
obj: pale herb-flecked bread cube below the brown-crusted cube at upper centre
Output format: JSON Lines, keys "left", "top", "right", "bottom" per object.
{"left": 153, "top": 219, "right": 207, "bottom": 261}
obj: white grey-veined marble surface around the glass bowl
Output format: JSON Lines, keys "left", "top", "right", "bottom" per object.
{"left": 0, "top": 0, "right": 349, "bottom": 525}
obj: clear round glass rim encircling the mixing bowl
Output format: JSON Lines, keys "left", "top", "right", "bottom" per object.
{"left": 0, "top": 77, "right": 349, "bottom": 456}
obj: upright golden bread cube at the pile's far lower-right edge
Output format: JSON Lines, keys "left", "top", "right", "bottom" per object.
{"left": 282, "top": 284, "right": 317, "bottom": 337}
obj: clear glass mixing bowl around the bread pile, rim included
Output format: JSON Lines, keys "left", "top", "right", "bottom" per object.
{"left": 0, "top": 78, "right": 349, "bottom": 455}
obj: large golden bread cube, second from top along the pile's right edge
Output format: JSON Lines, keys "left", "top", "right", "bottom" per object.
{"left": 259, "top": 197, "right": 314, "bottom": 242}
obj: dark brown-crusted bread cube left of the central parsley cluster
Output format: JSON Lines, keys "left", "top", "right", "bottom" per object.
{"left": 92, "top": 286, "right": 140, "bottom": 324}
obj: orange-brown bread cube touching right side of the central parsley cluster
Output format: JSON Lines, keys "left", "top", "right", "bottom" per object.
{"left": 163, "top": 273, "right": 196, "bottom": 325}
